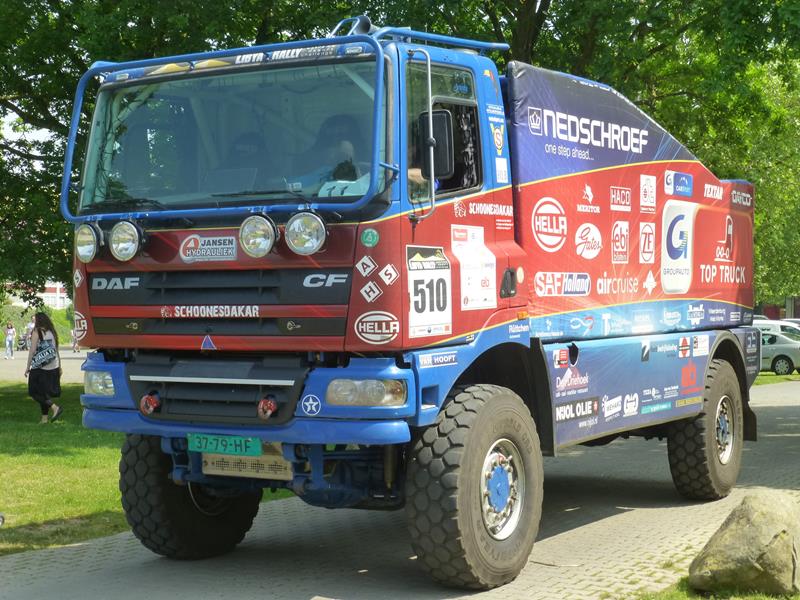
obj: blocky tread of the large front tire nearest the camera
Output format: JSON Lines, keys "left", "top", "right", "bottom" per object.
{"left": 406, "top": 384, "right": 538, "bottom": 589}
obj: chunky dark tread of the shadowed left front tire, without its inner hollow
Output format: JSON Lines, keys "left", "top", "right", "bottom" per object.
{"left": 119, "top": 434, "right": 261, "bottom": 560}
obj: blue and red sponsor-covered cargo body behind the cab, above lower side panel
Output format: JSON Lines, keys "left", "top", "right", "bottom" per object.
{"left": 504, "top": 62, "right": 753, "bottom": 341}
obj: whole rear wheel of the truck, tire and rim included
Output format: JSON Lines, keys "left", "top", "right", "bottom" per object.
{"left": 667, "top": 359, "right": 744, "bottom": 500}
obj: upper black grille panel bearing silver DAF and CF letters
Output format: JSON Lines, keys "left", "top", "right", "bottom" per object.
{"left": 89, "top": 268, "right": 352, "bottom": 306}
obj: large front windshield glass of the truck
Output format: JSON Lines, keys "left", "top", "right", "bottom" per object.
{"left": 80, "top": 60, "right": 383, "bottom": 214}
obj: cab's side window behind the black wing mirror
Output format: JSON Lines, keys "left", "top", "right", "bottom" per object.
{"left": 406, "top": 62, "right": 482, "bottom": 202}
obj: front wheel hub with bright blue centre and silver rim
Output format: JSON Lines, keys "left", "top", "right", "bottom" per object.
{"left": 480, "top": 439, "right": 525, "bottom": 540}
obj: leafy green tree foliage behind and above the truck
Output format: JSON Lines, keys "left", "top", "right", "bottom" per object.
{"left": 0, "top": 0, "right": 800, "bottom": 302}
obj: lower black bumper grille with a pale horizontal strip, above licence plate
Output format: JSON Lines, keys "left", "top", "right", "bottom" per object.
{"left": 127, "top": 352, "right": 309, "bottom": 427}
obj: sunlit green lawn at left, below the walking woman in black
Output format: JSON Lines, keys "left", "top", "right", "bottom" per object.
{"left": 0, "top": 382, "right": 291, "bottom": 556}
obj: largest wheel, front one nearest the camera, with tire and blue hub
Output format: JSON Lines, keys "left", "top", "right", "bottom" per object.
{"left": 406, "top": 385, "right": 543, "bottom": 589}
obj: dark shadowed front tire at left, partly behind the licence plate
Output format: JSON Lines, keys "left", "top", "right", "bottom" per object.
{"left": 119, "top": 435, "right": 261, "bottom": 560}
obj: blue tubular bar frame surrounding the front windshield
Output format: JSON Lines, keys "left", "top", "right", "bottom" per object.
{"left": 60, "top": 35, "right": 388, "bottom": 224}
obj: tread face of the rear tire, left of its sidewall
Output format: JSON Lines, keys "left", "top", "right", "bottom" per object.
{"left": 667, "top": 359, "right": 741, "bottom": 500}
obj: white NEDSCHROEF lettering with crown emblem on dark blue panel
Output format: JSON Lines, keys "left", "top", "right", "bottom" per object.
{"left": 528, "top": 106, "right": 648, "bottom": 154}
